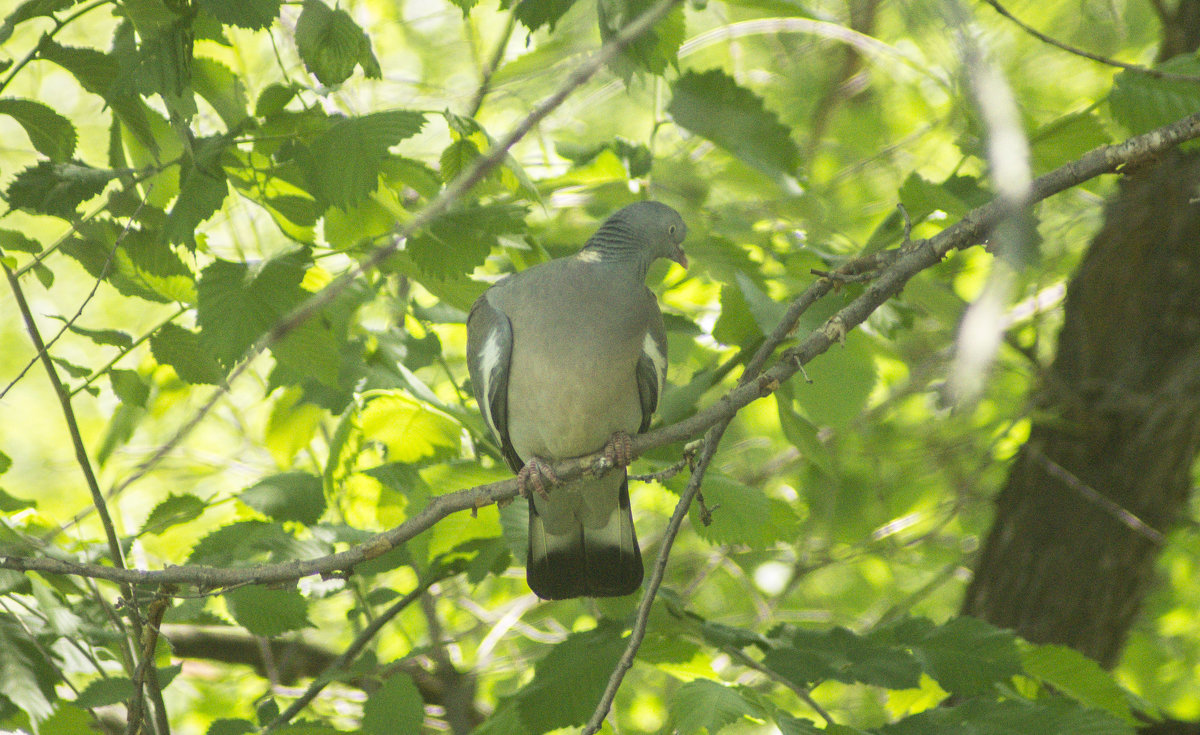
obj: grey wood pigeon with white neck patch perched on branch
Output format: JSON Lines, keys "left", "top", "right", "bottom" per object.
{"left": 467, "top": 202, "right": 688, "bottom": 599}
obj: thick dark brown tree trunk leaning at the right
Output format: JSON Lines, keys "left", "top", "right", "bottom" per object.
{"left": 962, "top": 153, "right": 1200, "bottom": 667}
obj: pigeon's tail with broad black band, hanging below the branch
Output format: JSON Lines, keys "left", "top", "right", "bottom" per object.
{"left": 526, "top": 477, "right": 642, "bottom": 599}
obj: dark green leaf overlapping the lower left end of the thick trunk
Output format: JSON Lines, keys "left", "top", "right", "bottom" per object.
{"left": 913, "top": 617, "right": 1022, "bottom": 696}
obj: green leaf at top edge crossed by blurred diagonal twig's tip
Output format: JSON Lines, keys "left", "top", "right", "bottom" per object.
{"left": 598, "top": 0, "right": 685, "bottom": 84}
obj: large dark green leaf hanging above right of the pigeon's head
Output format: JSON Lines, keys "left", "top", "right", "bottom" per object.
{"left": 667, "top": 68, "right": 800, "bottom": 175}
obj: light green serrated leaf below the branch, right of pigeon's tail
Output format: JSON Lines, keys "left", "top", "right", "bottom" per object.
{"left": 689, "top": 474, "right": 799, "bottom": 549}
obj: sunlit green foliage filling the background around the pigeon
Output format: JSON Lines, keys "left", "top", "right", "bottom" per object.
{"left": 0, "top": 0, "right": 1200, "bottom": 735}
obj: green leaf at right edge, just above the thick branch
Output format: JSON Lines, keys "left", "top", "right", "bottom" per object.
{"left": 1109, "top": 55, "right": 1200, "bottom": 136}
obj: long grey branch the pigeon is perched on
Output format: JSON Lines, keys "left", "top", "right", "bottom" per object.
{"left": 7, "top": 107, "right": 1200, "bottom": 587}
